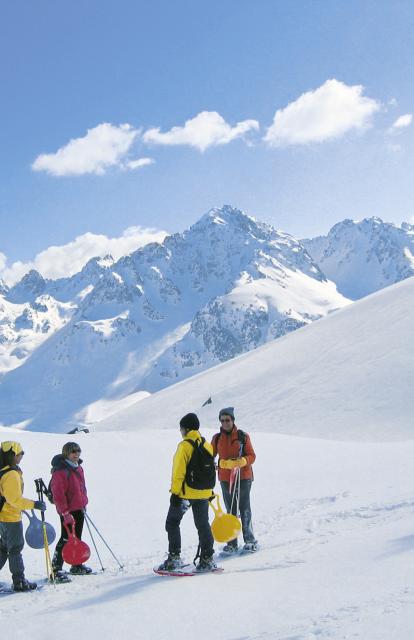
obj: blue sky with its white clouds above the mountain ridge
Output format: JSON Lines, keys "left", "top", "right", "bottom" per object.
{"left": 0, "top": 0, "right": 414, "bottom": 280}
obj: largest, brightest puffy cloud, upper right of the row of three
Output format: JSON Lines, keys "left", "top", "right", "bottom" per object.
{"left": 264, "top": 79, "right": 380, "bottom": 147}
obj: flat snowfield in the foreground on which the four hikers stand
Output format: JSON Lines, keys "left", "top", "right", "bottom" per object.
{"left": 0, "top": 422, "right": 414, "bottom": 640}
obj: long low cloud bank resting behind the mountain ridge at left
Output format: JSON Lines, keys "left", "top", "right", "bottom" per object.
{"left": 0, "top": 226, "right": 167, "bottom": 284}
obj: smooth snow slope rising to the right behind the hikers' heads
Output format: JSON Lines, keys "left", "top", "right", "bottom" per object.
{"left": 96, "top": 278, "right": 414, "bottom": 441}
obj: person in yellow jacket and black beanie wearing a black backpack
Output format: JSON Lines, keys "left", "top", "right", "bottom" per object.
{"left": 158, "top": 413, "right": 216, "bottom": 571}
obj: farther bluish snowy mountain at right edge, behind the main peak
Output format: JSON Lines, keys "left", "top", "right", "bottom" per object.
{"left": 302, "top": 218, "right": 414, "bottom": 300}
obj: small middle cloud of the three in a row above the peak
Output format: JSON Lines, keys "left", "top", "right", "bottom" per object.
{"left": 143, "top": 111, "right": 259, "bottom": 151}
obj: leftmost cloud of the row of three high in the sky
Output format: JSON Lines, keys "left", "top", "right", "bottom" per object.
{"left": 32, "top": 122, "right": 140, "bottom": 176}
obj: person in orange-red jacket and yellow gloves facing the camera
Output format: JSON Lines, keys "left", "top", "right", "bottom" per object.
{"left": 211, "top": 407, "right": 258, "bottom": 554}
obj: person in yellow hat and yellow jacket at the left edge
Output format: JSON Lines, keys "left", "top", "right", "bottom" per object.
{"left": 0, "top": 441, "right": 46, "bottom": 591}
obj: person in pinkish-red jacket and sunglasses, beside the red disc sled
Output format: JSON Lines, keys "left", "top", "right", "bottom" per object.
{"left": 50, "top": 442, "right": 92, "bottom": 581}
